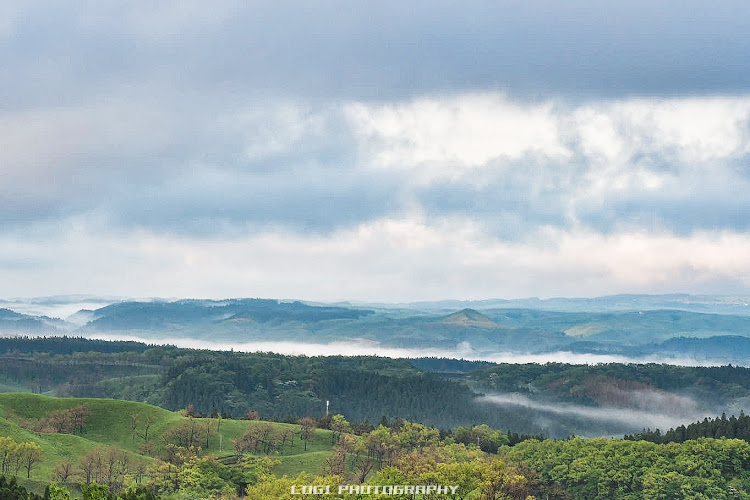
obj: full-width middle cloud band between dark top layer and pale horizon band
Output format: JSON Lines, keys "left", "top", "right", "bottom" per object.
{"left": 5, "top": 93, "right": 750, "bottom": 244}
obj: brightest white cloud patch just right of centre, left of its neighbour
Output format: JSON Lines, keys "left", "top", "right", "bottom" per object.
{"left": 346, "top": 94, "right": 570, "bottom": 180}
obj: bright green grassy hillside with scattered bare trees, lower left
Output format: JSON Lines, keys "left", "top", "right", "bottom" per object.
{"left": 0, "top": 393, "right": 331, "bottom": 490}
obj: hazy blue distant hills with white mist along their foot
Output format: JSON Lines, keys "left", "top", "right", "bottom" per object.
{"left": 7, "top": 294, "right": 750, "bottom": 364}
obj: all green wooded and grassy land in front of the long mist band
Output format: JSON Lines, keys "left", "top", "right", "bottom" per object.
{"left": 7, "top": 337, "right": 750, "bottom": 500}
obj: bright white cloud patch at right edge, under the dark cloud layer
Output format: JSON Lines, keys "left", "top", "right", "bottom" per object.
{"left": 562, "top": 96, "right": 750, "bottom": 197}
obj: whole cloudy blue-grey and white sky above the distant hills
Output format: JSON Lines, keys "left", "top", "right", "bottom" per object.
{"left": 0, "top": 0, "right": 750, "bottom": 302}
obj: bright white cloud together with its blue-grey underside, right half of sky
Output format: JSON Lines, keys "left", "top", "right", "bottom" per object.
{"left": 348, "top": 94, "right": 750, "bottom": 238}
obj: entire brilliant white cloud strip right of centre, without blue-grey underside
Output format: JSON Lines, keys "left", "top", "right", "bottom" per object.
{"left": 345, "top": 93, "right": 750, "bottom": 184}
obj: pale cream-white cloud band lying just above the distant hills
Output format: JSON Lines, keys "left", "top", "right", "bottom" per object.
{"left": 0, "top": 217, "right": 750, "bottom": 302}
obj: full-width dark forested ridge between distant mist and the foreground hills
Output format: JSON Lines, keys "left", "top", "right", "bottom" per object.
{"left": 7, "top": 337, "right": 750, "bottom": 437}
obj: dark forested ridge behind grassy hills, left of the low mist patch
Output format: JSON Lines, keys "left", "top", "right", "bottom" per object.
{"left": 0, "top": 338, "right": 516, "bottom": 427}
